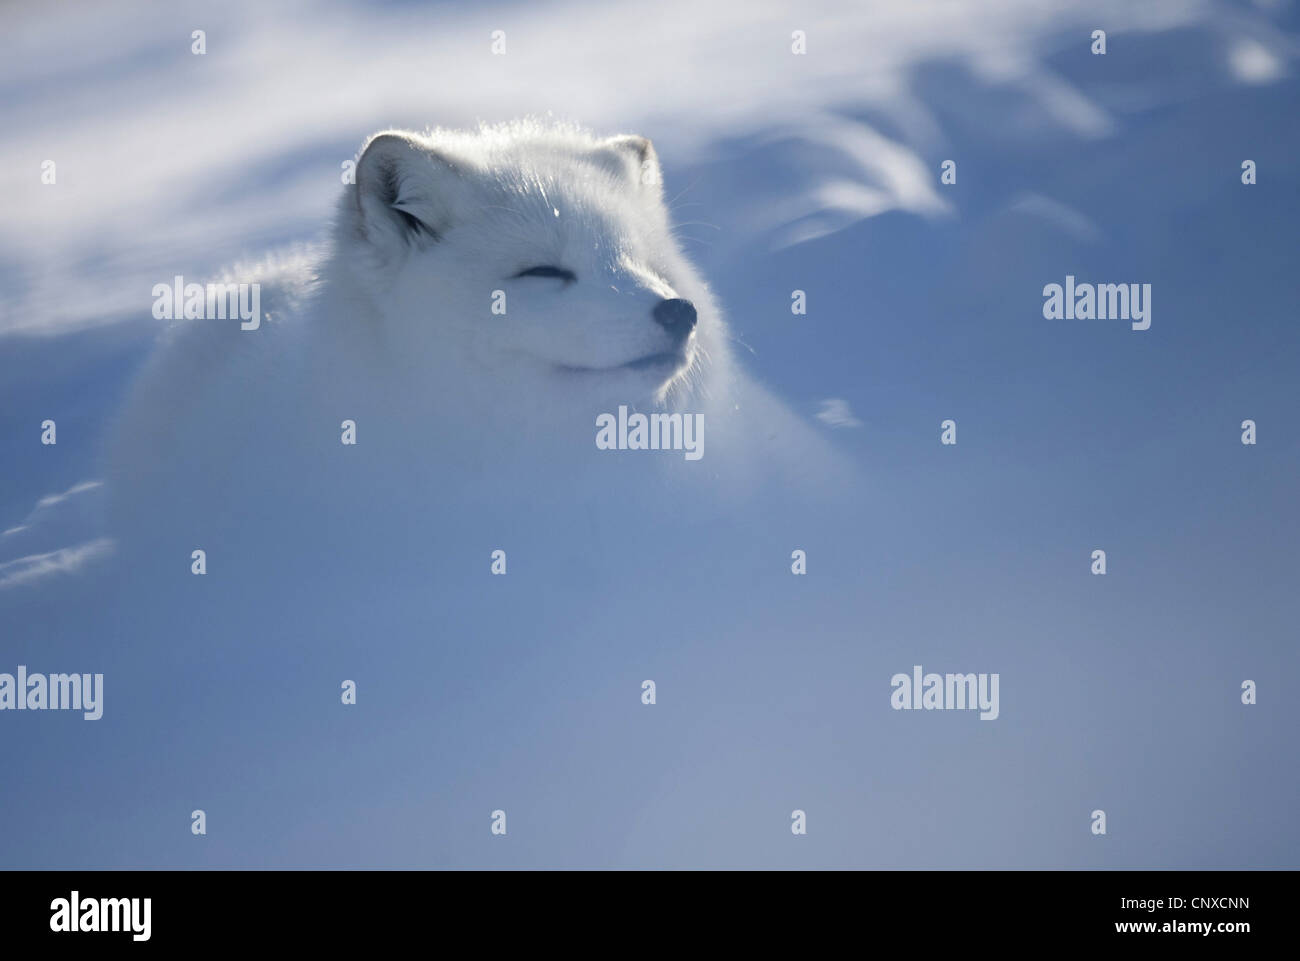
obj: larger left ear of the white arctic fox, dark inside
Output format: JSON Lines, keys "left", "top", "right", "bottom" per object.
{"left": 356, "top": 133, "right": 460, "bottom": 256}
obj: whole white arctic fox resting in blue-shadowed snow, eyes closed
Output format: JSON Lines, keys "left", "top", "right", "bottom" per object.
{"left": 111, "top": 122, "right": 842, "bottom": 566}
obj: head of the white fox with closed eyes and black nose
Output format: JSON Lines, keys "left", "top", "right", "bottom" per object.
{"left": 341, "top": 125, "right": 722, "bottom": 403}
